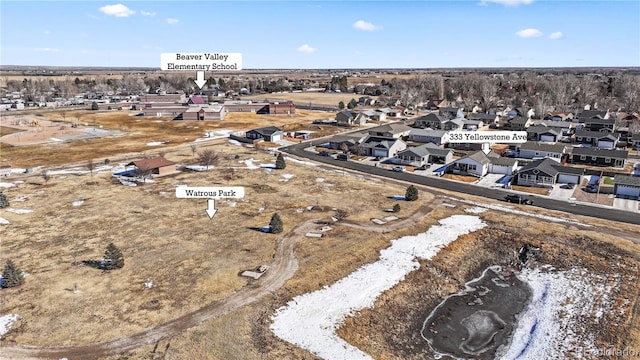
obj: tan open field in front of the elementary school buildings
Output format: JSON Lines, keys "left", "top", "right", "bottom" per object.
{"left": 0, "top": 110, "right": 339, "bottom": 168}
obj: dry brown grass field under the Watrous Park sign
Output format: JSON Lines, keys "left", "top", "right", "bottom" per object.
{"left": 0, "top": 145, "right": 429, "bottom": 345}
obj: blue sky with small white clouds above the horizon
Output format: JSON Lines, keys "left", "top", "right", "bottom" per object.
{"left": 0, "top": 0, "right": 640, "bottom": 69}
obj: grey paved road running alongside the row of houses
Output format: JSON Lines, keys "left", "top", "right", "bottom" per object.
{"left": 280, "top": 139, "right": 640, "bottom": 225}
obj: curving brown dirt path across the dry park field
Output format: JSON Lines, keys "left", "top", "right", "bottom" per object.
{"left": 0, "top": 204, "right": 433, "bottom": 360}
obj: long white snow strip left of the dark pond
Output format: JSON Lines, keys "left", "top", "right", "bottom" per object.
{"left": 271, "top": 215, "right": 486, "bottom": 360}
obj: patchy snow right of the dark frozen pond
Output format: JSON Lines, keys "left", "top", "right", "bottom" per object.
{"left": 496, "top": 267, "right": 620, "bottom": 360}
